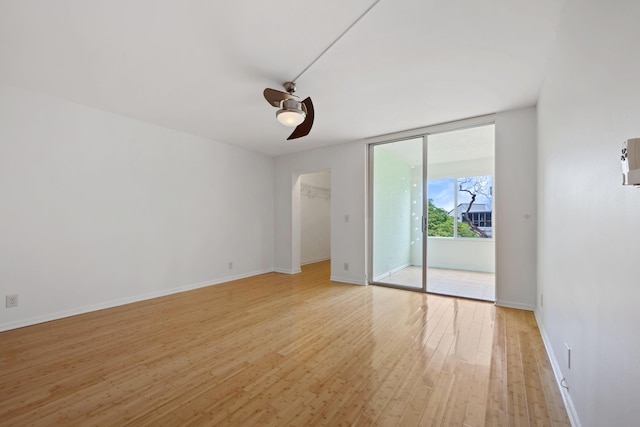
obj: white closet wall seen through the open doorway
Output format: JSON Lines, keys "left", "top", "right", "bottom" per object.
{"left": 300, "top": 171, "right": 331, "bottom": 264}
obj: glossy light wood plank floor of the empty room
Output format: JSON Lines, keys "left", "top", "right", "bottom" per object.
{"left": 0, "top": 262, "right": 569, "bottom": 426}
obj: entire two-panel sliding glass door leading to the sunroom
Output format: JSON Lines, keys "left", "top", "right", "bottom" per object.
{"left": 368, "top": 120, "right": 495, "bottom": 301}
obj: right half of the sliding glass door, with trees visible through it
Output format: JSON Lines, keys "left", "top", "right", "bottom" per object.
{"left": 426, "top": 124, "right": 495, "bottom": 301}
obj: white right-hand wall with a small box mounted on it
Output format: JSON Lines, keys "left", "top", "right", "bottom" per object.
{"left": 536, "top": 0, "right": 640, "bottom": 427}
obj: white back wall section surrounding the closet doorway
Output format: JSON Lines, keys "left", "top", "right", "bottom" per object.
{"left": 275, "top": 142, "right": 366, "bottom": 284}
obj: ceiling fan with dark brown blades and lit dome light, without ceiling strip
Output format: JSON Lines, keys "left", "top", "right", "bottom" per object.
{"left": 263, "top": 82, "right": 314, "bottom": 140}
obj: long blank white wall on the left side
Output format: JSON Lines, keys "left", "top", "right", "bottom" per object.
{"left": 0, "top": 86, "right": 273, "bottom": 329}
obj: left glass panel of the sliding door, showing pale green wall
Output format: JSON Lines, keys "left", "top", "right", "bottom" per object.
{"left": 369, "top": 137, "right": 425, "bottom": 290}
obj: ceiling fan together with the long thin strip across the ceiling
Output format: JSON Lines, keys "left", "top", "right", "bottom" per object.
{"left": 263, "top": 0, "right": 380, "bottom": 140}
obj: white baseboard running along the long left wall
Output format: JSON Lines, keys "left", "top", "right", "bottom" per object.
{"left": 0, "top": 268, "right": 274, "bottom": 332}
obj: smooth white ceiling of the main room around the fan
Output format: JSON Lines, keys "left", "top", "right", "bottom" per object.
{"left": 0, "top": 0, "right": 562, "bottom": 155}
